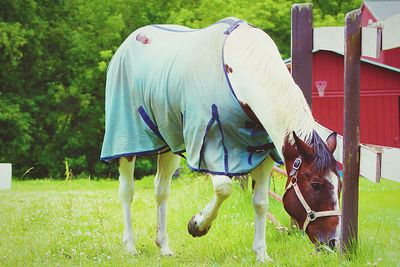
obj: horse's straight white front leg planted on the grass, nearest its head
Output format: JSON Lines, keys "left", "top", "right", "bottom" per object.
{"left": 251, "top": 157, "right": 274, "bottom": 262}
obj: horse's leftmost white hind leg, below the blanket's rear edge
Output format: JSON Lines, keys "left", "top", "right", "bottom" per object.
{"left": 118, "top": 157, "right": 137, "bottom": 254}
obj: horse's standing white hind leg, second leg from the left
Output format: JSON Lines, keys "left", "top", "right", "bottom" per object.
{"left": 154, "top": 152, "right": 180, "bottom": 256}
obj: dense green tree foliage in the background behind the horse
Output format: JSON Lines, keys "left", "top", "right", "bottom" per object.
{"left": 0, "top": 0, "right": 360, "bottom": 178}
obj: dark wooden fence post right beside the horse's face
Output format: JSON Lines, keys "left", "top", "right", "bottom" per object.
{"left": 341, "top": 9, "right": 361, "bottom": 254}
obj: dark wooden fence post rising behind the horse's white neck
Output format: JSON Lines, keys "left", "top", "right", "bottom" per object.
{"left": 291, "top": 4, "right": 313, "bottom": 107}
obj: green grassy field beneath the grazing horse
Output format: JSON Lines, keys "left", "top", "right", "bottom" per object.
{"left": 0, "top": 173, "right": 400, "bottom": 266}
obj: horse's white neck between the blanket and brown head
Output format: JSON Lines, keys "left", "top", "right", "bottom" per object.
{"left": 224, "top": 26, "right": 314, "bottom": 157}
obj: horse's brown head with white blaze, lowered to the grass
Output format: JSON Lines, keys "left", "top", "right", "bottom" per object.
{"left": 283, "top": 132, "right": 341, "bottom": 248}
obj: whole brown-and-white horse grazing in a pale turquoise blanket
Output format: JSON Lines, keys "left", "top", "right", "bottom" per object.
{"left": 101, "top": 17, "right": 341, "bottom": 262}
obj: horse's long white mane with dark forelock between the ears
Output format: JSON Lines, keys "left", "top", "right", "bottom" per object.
{"left": 245, "top": 30, "right": 335, "bottom": 173}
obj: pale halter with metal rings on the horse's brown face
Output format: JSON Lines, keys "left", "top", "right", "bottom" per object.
{"left": 282, "top": 158, "right": 342, "bottom": 232}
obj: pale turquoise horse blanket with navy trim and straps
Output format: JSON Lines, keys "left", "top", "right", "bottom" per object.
{"left": 101, "top": 18, "right": 279, "bottom": 176}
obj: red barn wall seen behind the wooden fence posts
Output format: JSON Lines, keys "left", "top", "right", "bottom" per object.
{"left": 312, "top": 51, "right": 400, "bottom": 147}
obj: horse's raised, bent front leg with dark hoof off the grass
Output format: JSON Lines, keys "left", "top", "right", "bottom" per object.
{"left": 188, "top": 175, "right": 232, "bottom": 237}
